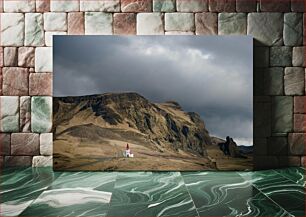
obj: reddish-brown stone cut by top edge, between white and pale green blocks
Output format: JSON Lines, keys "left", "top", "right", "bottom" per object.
{"left": 121, "top": 0, "right": 152, "bottom": 12}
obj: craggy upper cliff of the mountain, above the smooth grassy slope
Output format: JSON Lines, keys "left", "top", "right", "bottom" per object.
{"left": 53, "top": 93, "right": 211, "bottom": 156}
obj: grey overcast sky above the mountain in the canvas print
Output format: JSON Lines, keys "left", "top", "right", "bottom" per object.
{"left": 53, "top": 36, "right": 253, "bottom": 145}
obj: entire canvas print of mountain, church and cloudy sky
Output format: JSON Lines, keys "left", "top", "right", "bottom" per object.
{"left": 53, "top": 35, "right": 253, "bottom": 171}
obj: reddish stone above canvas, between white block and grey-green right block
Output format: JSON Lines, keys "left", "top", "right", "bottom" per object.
{"left": 195, "top": 12, "right": 218, "bottom": 35}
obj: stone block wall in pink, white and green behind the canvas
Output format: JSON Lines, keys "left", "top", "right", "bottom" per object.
{"left": 0, "top": 0, "right": 306, "bottom": 169}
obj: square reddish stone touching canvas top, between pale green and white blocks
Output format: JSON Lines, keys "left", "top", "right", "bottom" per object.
{"left": 113, "top": 13, "right": 136, "bottom": 35}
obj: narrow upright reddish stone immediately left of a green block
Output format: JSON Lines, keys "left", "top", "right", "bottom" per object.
{"left": 19, "top": 96, "right": 31, "bottom": 133}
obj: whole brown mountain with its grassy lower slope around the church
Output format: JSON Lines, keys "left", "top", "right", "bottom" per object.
{"left": 53, "top": 92, "right": 214, "bottom": 170}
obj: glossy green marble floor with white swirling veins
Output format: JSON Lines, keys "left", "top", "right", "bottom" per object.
{"left": 0, "top": 168, "right": 305, "bottom": 216}
